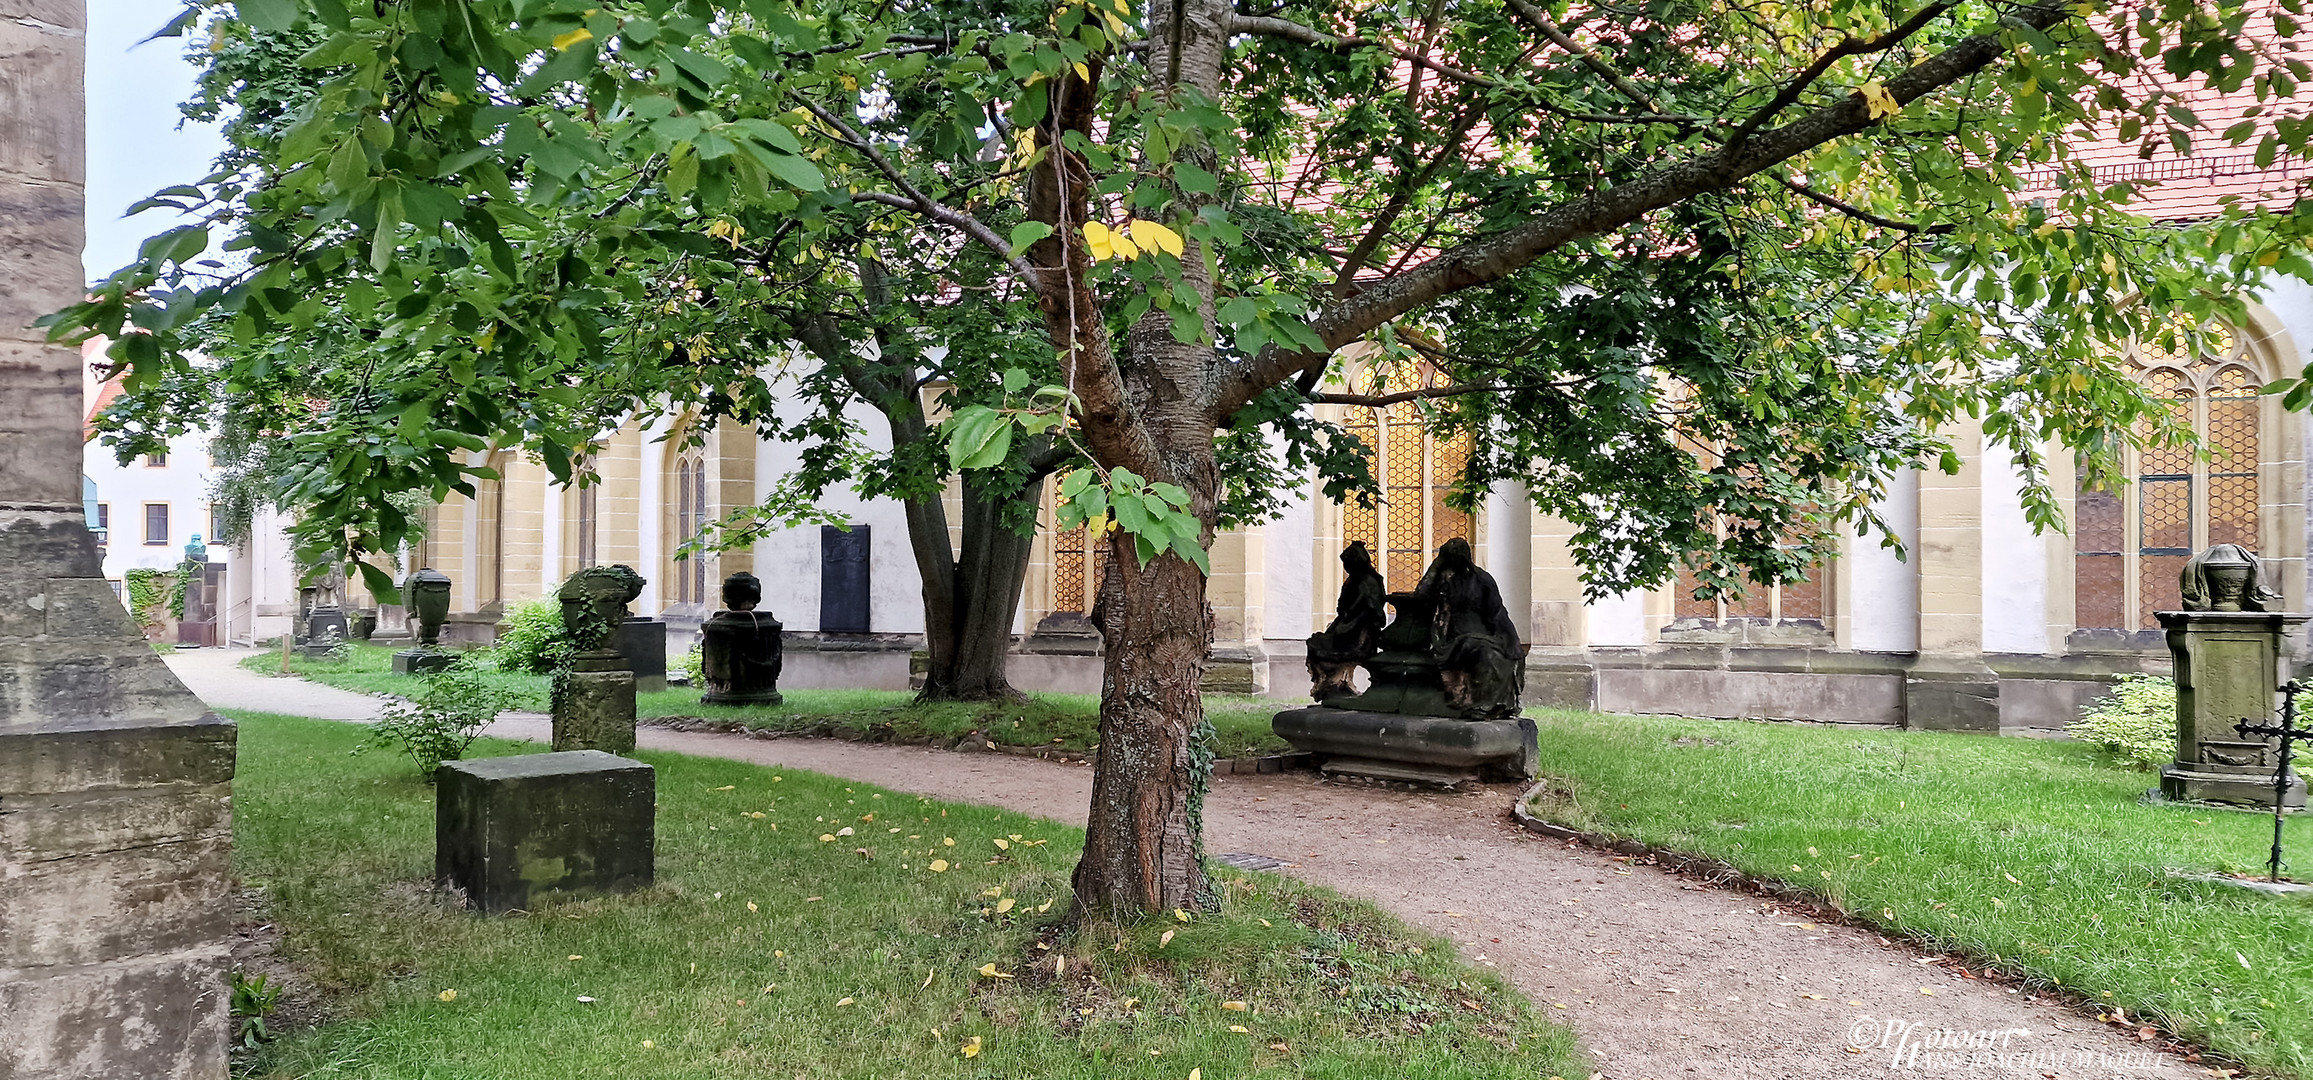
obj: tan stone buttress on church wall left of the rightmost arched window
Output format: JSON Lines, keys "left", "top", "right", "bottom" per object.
{"left": 1904, "top": 421, "right": 1998, "bottom": 733}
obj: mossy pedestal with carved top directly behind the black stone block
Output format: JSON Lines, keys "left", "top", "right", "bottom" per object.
{"left": 553, "top": 567, "right": 643, "bottom": 754}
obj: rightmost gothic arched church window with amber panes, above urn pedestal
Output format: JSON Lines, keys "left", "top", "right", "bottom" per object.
{"left": 2072, "top": 328, "right": 2264, "bottom": 629}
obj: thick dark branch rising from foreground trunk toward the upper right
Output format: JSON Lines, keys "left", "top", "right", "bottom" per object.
{"left": 1212, "top": 0, "right": 2072, "bottom": 416}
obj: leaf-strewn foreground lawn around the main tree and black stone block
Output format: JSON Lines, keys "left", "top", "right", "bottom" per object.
{"left": 234, "top": 715, "right": 1589, "bottom": 1080}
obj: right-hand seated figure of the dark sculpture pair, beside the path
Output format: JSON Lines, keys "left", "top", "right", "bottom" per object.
{"left": 1413, "top": 537, "right": 1527, "bottom": 719}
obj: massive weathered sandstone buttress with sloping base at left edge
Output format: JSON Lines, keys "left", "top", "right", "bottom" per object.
{"left": 0, "top": 0, "right": 234, "bottom": 1080}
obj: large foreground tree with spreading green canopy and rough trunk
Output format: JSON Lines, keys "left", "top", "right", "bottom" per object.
{"left": 53, "top": 0, "right": 2313, "bottom": 909}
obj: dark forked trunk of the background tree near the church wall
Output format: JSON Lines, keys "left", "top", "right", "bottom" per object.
{"left": 909, "top": 472, "right": 1034, "bottom": 701}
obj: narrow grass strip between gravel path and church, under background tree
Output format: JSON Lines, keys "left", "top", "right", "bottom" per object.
{"left": 255, "top": 643, "right": 1288, "bottom": 759}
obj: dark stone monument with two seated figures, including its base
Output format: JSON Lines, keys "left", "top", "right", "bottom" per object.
{"left": 1270, "top": 539, "right": 1536, "bottom": 786}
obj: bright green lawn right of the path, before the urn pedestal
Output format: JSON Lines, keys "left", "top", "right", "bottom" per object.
{"left": 1531, "top": 712, "right": 2313, "bottom": 1073}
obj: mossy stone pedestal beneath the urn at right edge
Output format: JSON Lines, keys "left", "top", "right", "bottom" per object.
{"left": 2158, "top": 611, "right": 2313, "bottom": 807}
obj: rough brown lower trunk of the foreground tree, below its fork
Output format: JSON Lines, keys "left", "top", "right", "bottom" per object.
{"left": 1071, "top": 532, "right": 1214, "bottom": 920}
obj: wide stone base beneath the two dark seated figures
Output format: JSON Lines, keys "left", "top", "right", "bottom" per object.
{"left": 1270, "top": 705, "right": 1536, "bottom": 786}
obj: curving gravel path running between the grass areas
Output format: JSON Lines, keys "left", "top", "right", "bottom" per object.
{"left": 169, "top": 650, "right": 2211, "bottom": 1080}
